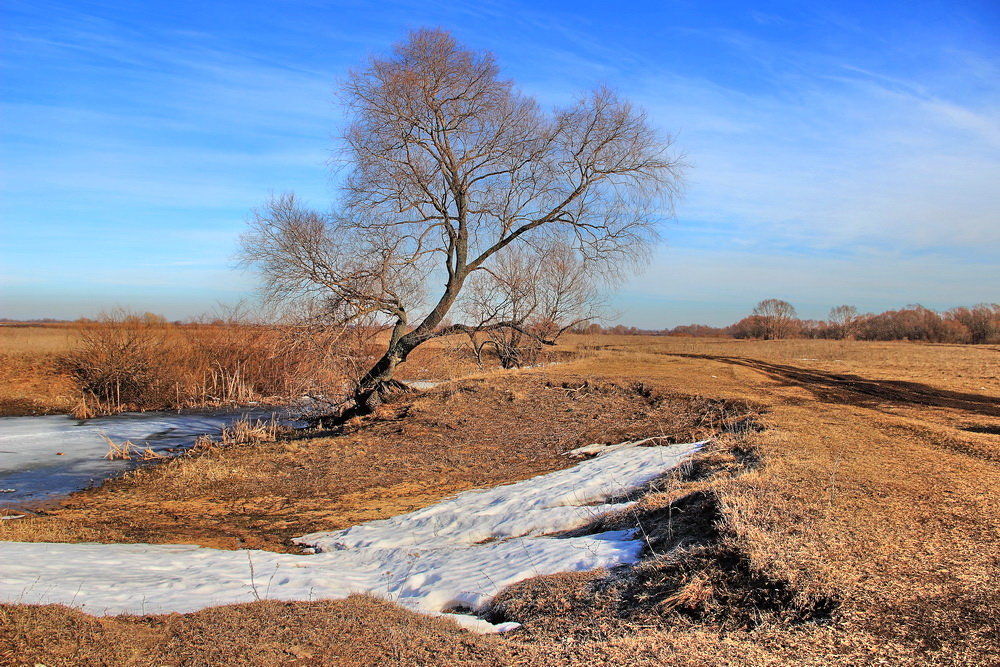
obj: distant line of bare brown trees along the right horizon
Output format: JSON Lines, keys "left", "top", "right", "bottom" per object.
{"left": 575, "top": 299, "right": 1000, "bottom": 344}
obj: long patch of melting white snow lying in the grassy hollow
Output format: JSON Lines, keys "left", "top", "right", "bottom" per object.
{"left": 0, "top": 443, "right": 703, "bottom": 632}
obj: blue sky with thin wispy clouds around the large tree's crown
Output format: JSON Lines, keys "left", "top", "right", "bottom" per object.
{"left": 0, "top": 0, "right": 1000, "bottom": 328}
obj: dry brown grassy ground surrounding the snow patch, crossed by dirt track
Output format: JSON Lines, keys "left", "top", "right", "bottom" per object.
{"left": 0, "top": 330, "right": 1000, "bottom": 665}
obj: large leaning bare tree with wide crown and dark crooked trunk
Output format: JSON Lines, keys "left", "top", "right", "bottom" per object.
{"left": 242, "top": 30, "right": 683, "bottom": 418}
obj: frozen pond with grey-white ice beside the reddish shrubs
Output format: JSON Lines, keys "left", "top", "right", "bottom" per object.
{"left": 0, "top": 410, "right": 282, "bottom": 508}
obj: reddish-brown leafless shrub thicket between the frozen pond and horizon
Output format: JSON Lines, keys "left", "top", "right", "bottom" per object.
{"left": 59, "top": 312, "right": 343, "bottom": 417}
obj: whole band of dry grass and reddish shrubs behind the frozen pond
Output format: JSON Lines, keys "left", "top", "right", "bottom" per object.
{"left": 0, "top": 312, "right": 320, "bottom": 418}
